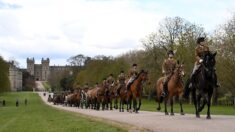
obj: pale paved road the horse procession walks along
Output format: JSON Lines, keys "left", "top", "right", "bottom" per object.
{"left": 39, "top": 93, "right": 235, "bottom": 132}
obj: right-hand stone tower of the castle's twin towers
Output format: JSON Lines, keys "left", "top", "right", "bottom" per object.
{"left": 41, "top": 58, "right": 50, "bottom": 81}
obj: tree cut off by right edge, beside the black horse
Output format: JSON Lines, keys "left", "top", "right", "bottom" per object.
{"left": 212, "top": 13, "right": 235, "bottom": 96}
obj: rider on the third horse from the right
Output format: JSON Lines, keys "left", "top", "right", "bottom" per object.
{"left": 126, "top": 64, "right": 138, "bottom": 91}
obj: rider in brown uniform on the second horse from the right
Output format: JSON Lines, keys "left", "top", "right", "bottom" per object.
{"left": 161, "top": 50, "right": 177, "bottom": 97}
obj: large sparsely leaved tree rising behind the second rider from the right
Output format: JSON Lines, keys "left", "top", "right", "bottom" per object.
{"left": 140, "top": 17, "right": 206, "bottom": 97}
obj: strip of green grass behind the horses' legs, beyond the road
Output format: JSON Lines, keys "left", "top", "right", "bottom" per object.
{"left": 141, "top": 99, "right": 235, "bottom": 115}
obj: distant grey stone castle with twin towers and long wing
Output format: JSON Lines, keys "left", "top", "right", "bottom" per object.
{"left": 27, "top": 58, "right": 71, "bottom": 81}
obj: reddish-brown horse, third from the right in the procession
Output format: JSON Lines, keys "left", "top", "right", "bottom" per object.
{"left": 127, "top": 70, "right": 148, "bottom": 113}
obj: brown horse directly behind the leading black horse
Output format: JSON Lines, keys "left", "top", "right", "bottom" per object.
{"left": 156, "top": 63, "right": 185, "bottom": 115}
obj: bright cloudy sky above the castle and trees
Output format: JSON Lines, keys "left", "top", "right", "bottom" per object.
{"left": 0, "top": 0, "right": 235, "bottom": 68}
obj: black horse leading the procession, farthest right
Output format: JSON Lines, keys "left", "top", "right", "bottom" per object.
{"left": 185, "top": 51, "right": 216, "bottom": 119}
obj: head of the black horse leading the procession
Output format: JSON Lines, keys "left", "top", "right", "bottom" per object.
{"left": 203, "top": 52, "right": 217, "bottom": 77}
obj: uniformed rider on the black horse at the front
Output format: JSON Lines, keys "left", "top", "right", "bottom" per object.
{"left": 189, "top": 37, "right": 219, "bottom": 87}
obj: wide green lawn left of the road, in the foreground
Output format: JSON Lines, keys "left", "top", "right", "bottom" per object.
{"left": 0, "top": 92, "right": 126, "bottom": 132}
